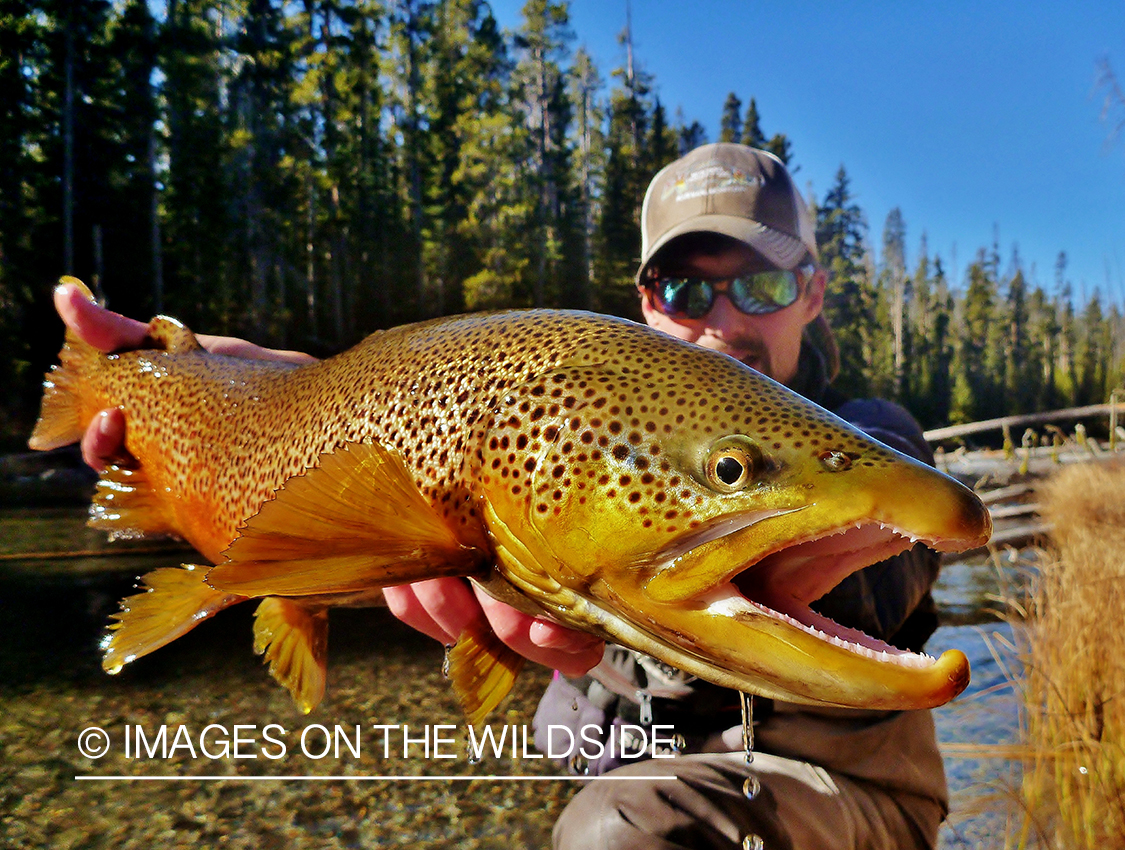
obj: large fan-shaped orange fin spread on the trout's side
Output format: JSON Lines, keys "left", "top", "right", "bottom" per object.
{"left": 207, "top": 443, "right": 486, "bottom": 596}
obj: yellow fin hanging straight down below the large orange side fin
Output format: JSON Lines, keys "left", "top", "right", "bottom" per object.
{"left": 254, "top": 597, "right": 329, "bottom": 714}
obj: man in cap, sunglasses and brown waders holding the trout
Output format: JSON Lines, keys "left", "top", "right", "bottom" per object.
{"left": 56, "top": 144, "right": 946, "bottom": 849}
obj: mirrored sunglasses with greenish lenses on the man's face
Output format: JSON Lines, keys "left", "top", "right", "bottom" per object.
{"left": 648, "top": 268, "right": 812, "bottom": 319}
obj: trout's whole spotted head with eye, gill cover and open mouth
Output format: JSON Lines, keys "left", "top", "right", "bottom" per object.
{"left": 482, "top": 326, "right": 991, "bottom": 709}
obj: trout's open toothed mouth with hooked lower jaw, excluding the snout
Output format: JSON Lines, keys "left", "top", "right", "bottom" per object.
{"left": 601, "top": 506, "right": 987, "bottom": 709}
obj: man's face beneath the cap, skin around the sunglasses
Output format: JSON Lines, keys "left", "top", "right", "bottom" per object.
{"left": 640, "top": 244, "right": 825, "bottom": 383}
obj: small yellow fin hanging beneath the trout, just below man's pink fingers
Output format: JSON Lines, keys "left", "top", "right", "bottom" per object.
{"left": 449, "top": 623, "right": 524, "bottom": 726}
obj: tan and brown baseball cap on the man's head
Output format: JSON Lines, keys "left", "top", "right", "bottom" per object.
{"left": 638, "top": 142, "right": 817, "bottom": 280}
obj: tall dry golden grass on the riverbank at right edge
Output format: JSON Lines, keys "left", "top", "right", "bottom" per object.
{"left": 1009, "top": 463, "right": 1125, "bottom": 850}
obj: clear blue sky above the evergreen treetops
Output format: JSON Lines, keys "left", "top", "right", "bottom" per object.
{"left": 492, "top": 0, "right": 1125, "bottom": 304}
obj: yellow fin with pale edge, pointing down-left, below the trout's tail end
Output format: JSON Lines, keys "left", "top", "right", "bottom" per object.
{"left": 101, "top": 563, "right": 244, "bottom": 675}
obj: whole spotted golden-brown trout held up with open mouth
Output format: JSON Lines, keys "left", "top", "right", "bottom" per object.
{"left": 30, "top": 278, "right": 991, "bottom": 723}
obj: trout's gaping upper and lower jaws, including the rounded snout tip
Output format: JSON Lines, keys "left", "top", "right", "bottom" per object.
{"left": 593, "top": 458, "right": 991, "bottom": 709}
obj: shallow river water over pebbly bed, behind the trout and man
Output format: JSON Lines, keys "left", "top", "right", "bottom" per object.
{"left": 0, "top": 509, "right": 1019, "bottom": 850}
